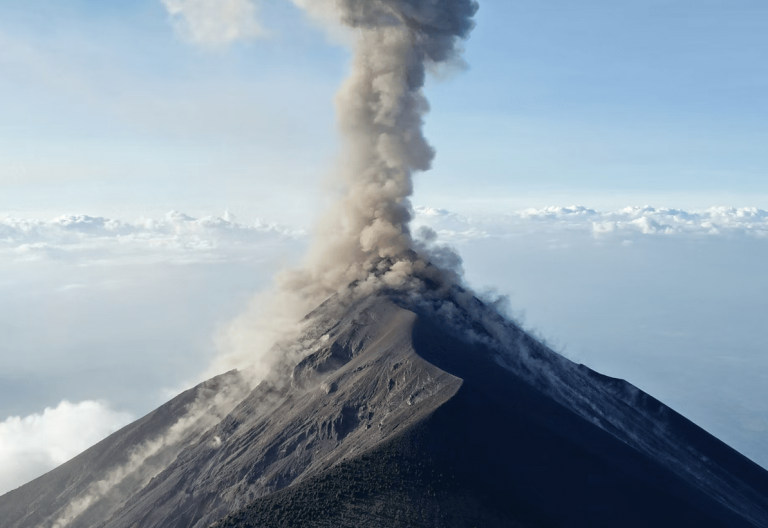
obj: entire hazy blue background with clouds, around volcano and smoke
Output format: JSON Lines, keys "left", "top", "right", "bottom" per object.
{"left": 0, "top": 0, "right": 768, "bottom": 493}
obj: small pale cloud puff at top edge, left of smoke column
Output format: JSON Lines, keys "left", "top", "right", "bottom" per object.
{"left": 161, "top": 0, "right": 265, "bottom": 48}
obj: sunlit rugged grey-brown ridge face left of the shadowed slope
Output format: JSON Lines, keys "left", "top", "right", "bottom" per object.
{"left": 92, "top": 294, "right": 461, "bottom": 528}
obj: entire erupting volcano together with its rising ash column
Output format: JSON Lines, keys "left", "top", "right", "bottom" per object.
{"left": 0, "top": 0, "right": 768, "bottom": 528}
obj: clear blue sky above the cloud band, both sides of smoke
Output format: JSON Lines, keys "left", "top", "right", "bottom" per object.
{"left": 0, "top": 0, "right": 768, "bottom": 221}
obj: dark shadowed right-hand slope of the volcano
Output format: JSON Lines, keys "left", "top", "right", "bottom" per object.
{"left": 210, "top": 294, "right": 768, "bottom": 528}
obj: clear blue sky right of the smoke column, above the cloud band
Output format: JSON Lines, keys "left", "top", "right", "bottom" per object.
{"left": 420, "top": 1, "right": 768, "bottom": 205}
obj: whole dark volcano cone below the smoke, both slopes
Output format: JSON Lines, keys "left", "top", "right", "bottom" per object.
{"left": 0, "top": 291, "right": 768, "bottom": 528}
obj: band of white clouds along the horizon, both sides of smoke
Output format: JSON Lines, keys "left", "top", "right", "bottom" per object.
{"left": 0, "top": 206, "right": 768, "bottom": 264}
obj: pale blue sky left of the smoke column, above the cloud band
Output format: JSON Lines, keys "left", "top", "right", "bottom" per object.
{"left": 0, "top": 1, "right": 346, "bottom": 221}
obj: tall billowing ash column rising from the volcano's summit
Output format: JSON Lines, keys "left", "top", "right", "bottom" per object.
{"left": 282, "top": 0, "right": 478, "bottom": 305}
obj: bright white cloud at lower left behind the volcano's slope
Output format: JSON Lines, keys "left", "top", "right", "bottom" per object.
{"left": 0, "top": 400, "right": 133, "bottom": 494}
